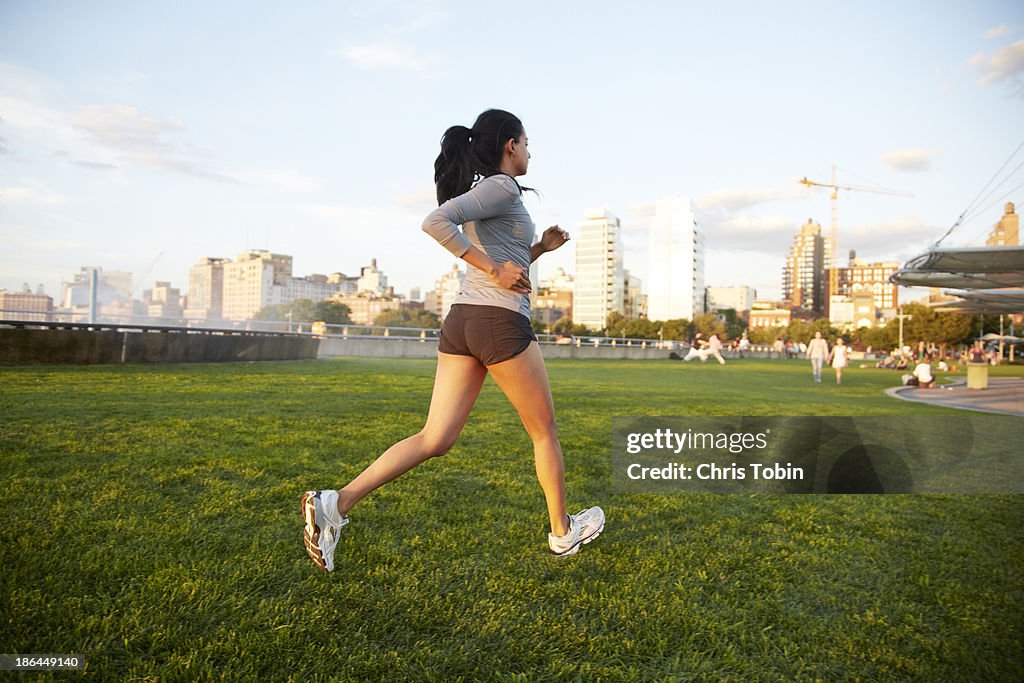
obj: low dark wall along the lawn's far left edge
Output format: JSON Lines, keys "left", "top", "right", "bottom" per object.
{"left": 0, "top": 329, "right": 318, "bottom": 366}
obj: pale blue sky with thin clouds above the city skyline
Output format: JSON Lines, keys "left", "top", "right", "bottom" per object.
{"left": 0, "top": 0, "right": 1024, "bottom": 305}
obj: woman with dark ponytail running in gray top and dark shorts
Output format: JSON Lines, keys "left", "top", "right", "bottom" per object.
{"left": 301, "top": 110, "right": 604, "bottom": 571}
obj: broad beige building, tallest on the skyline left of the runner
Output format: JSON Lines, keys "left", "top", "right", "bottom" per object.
{"left": 223, "top": 250, "right": 292, "bottom": 321}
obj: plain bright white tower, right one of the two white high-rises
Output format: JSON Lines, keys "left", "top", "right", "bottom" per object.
{"left": 647, "top": 197, "right": 705, "bottom": 321}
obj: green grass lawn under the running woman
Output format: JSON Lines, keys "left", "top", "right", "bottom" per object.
{"left": 0, "top": 359, "right": 1024, "bottom": 681}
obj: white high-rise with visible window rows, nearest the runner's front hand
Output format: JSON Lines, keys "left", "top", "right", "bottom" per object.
{"left": 572, "top": 209, "right": 626, "bottom": 330}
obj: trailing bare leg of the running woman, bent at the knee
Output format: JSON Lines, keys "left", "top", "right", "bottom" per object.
{"left": 338, "top": 352, "right": 487, "bottom": 516}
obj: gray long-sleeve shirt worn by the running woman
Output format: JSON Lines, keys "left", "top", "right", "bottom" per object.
{"left": 423, "top": 174, "right": 536, "bottom": 317}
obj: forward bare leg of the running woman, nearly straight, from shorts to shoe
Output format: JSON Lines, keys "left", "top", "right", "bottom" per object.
{"left": 487, "top": 342, "right": 568, "bottom": 536}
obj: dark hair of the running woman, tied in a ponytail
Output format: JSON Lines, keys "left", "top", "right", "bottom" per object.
{"left": 434, "top": 110, "right": 525, "bottom": 205}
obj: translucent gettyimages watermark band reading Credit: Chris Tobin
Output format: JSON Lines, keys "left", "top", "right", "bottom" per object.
{"left": 611, "top": 414, "right": 1024, "bottom": 494}
